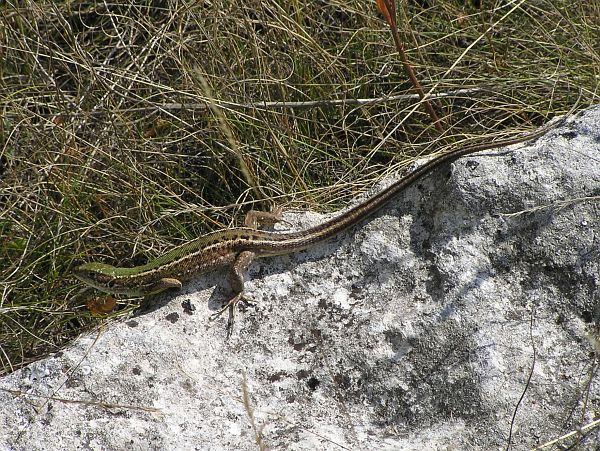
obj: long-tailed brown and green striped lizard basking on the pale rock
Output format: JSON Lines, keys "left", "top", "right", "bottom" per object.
{"left": 73, "top": 121, "right": 563, "bottom": 320}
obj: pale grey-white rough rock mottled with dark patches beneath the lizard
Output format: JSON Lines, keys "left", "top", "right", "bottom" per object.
{"left": 0, "top": 108, "right": 600, "bottom": 450}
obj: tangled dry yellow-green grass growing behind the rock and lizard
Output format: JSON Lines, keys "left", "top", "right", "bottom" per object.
{"left": 0, "top": 0, "right": 600, "bottom": 374}
